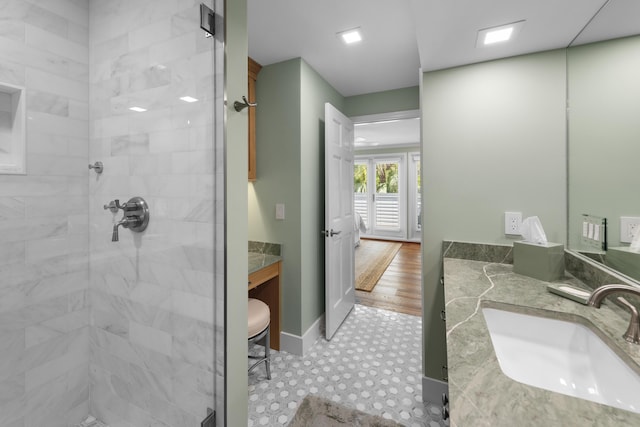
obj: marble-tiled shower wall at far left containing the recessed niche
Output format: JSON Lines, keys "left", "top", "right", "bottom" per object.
{"left": 0, "top": 0, "right": 90, "bottom": 427}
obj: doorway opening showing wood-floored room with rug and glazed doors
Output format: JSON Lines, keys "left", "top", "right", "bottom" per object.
{"left": 353, "top": 111, "right": 422, "bottom": 316}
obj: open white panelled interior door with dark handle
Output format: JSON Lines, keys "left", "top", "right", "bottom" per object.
{"left": 323, "top": 103, "right": 355, "bottom": 340}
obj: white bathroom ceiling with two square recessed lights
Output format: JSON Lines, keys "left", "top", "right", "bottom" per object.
{"left": 248, "top": 0, "right": 640, "bottom": 96}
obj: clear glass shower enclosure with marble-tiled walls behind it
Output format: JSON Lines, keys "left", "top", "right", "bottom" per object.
{"left": 0, "top": 0, "right": 224, "bottom": 427}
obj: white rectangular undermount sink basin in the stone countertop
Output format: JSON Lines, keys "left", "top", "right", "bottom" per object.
{"left": 482, "top": 308, "right": 640, "bottom": 413}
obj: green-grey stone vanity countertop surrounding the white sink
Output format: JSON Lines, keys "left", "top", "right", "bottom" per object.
{"left": 444, "top": 258, "right": 640, "bottom": 427}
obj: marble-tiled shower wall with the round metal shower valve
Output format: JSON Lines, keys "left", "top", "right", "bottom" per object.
{"left": 89, "top": 0, "right": 216, "bottom": 427}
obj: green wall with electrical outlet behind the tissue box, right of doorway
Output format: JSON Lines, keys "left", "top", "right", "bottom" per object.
{"left": 421, "top": 50, "right": 566, "bottom": 380}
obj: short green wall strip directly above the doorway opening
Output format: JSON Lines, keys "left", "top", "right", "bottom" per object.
{"left": 343, "top": 86, "right": 420, "bottom": 117}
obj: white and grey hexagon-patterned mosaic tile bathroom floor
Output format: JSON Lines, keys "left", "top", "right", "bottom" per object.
{"left": 249, "top": 305, "right": 447, "bottom": 427}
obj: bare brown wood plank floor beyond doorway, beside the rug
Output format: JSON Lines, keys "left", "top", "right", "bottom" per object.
{"left": 356, "top": 242, "right": 422, "bottom": 316}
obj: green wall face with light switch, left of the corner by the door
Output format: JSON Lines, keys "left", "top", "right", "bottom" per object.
{"left": 249, "top": 59, "right": 302, "bottom": 335}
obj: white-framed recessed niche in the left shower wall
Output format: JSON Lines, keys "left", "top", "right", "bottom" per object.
{"left": 0, "top": 82, "right": 26, "bottom": 175}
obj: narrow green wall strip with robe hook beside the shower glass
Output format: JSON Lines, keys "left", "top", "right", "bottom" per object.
{"left": 224, "top": 0, "right": 248, "bottom": 426}
